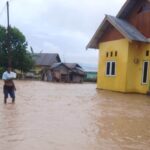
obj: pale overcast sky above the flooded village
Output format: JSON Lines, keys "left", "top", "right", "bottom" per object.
{"left": 0, "top": 0, "right": 126, "bottom": 65}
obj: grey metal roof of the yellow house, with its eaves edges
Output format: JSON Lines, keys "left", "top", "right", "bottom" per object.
{"left": 86, "top": 0, "right": 150, "bottom": 49}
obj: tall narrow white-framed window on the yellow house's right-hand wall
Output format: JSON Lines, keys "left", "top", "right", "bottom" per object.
{"left": 142, "top": 61, "right": 149, "bottom": 84}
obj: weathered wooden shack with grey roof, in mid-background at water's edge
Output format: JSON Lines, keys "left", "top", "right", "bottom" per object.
{"left": 51, "top": 63, "right": 85, "bottom": 83}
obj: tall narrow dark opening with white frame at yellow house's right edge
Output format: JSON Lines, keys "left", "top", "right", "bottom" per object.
{"left": 142, "top": 61, "right": 150, "bottom": 84}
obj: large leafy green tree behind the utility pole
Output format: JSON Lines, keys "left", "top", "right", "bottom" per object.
{"left": 0, "top": 26, "right": 34, "bottom": 72}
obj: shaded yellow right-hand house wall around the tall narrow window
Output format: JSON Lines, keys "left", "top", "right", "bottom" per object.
{"left": 127, "top": 42, "right": 150, "bottom": 93}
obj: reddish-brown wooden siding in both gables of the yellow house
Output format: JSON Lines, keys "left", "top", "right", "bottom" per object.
{"left": 100, "top": 0, "right": 150, "bottom": 42}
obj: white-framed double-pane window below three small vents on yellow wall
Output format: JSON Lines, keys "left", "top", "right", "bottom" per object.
{"left": 106, "top": 61, "right": 116, "bottom": 76}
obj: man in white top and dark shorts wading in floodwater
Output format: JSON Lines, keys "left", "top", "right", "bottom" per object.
{"left": 2, "top": 67, "right": 16, "bottom": 104}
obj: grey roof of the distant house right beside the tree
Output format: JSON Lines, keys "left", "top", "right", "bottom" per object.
{"left": 33, "top": 53, "right": 61, "bottom": 66}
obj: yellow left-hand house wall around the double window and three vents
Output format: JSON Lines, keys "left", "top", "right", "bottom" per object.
{"left": 97, "top": 39, "right": 129, "bottom": 92}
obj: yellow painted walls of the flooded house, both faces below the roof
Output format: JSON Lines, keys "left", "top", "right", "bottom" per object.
{"left": 97, "top": 39, "right": 150, "bottom": 93}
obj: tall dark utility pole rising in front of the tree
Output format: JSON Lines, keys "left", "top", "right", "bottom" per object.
{"left": 6, "top": 1, "right": 12, "bottom": 67}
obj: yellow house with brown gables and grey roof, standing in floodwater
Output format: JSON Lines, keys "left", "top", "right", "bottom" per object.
{"left": 87, "top": 0, "right": 150, "bottom": 93}
